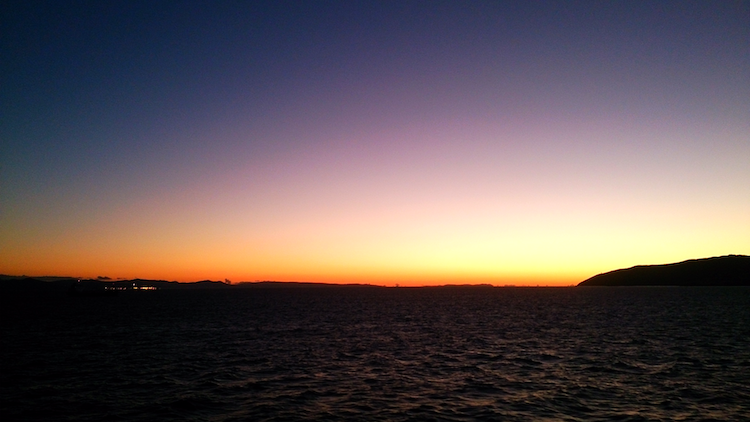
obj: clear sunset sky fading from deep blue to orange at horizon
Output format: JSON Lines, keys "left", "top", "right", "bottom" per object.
{"left": 0, "top": 0, "right": 750, "bottom": 285}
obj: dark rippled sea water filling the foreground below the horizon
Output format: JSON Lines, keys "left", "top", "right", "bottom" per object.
{"left": 0, "top": 287, "right": 750, "bottom": 421}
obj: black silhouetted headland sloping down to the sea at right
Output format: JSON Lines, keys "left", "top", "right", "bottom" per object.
{"left": 578, "top": 255, "right": 750, "bottom": 286}
